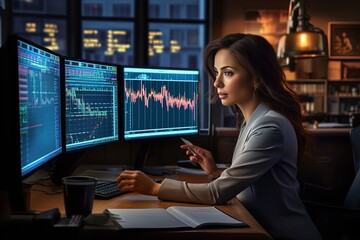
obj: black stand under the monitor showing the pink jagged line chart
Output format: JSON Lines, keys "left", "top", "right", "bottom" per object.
{"left": 134, "top": 141, "right": 174, "bottom": 175}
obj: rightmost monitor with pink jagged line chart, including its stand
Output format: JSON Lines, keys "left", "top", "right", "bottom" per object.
{"left": 121, "top": 66, "right": 200, "bottom": 174}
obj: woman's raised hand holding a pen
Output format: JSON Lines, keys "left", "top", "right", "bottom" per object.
{"left": 180, "top": 144, "right": 221, "bottom": 177}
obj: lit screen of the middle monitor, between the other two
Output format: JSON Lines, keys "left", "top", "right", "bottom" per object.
{"left": 64, "top": 58, "right": 120, "bottom": 152}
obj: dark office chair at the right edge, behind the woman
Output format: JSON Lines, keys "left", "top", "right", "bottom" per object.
{"left": 303, "top": 127, "right": 360, "bottom": 240}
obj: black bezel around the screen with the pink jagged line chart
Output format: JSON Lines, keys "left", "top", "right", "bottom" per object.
{"left": 121, "top": 65, "right": 201, "bottom": 143}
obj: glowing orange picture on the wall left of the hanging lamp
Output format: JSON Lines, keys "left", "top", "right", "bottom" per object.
{"left": 244, "top": 9, "right": 288, "bottom": 50}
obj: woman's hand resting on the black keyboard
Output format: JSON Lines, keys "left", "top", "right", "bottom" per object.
{"left": 117, "top": 170, "right": 160, "bottom": 196}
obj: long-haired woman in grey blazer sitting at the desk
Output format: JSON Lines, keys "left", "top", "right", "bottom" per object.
{"left": 118, "top": 33, "right": 321, "bottom": 240}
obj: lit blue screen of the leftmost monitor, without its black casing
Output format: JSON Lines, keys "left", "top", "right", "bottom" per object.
{"left": 17, "top": 36, "right": 62, "bottom": 176}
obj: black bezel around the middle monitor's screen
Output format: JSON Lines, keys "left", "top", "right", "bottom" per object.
{"left": 62, "top": 56, "right": 123, "bottom": 154}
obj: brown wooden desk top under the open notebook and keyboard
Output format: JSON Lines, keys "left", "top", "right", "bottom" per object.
{"left": 30, "top": 169, "right": 271, "bottom": 240}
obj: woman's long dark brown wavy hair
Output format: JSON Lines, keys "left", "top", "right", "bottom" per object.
{"left": 204, "top": 33, "right": 309, "bottom": 158}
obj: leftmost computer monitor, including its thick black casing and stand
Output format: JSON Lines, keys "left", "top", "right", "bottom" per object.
{"left": 1, "top": 35, "right": 62, "bottom": 211}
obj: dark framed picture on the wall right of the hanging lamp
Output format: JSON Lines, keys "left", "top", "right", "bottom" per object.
{"left": 328, "top": 22, "right": 360, "bottom": 59}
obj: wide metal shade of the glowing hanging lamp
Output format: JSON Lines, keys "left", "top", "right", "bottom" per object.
{"left": 278, "top": 31, "right": 327, "bottom": 58}
